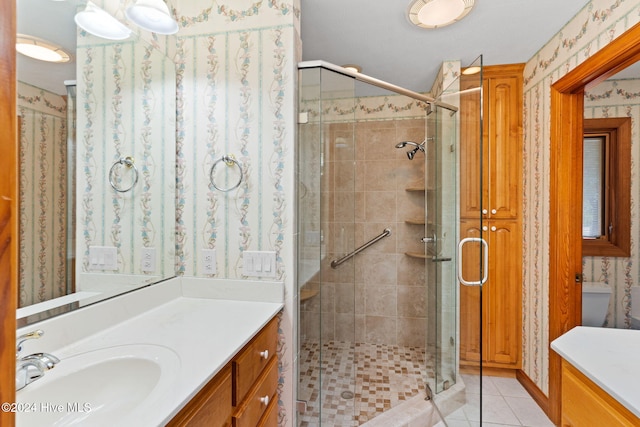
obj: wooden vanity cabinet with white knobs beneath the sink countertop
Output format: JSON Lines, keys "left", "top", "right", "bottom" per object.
{"left": 167, "top": 317, "right": 279, "bottom": 427}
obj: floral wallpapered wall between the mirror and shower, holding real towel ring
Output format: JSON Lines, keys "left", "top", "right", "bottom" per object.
{"left": 170, "top": 0, "right": 300, "bottom": 425}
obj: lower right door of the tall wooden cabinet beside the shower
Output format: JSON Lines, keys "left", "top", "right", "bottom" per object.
{"left": 483, "top": 221, "right": 522, "bottom": 368}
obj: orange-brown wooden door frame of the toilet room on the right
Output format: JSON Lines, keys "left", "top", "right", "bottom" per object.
{"left": 548, "top": 23, "right": 640, "bottom": 425}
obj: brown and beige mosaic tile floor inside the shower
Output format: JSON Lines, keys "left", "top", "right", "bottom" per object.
{"left": 298, "top": 341, "right": 434, "bottom": 427}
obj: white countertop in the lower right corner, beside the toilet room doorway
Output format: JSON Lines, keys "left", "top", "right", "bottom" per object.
{"left": 551, "top": 326, "right": 640, "bottom": 417}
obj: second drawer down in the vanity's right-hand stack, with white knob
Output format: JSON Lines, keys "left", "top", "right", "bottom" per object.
{"left": 233, "top": 357, "right": 278, "bottom": 427}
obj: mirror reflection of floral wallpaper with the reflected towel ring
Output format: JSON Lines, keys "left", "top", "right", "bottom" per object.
{"left": 76, "top": 32, "right": 175, "bottom": 282}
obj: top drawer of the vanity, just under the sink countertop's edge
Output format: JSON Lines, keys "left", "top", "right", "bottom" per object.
{"left": 233, "top": 317, "right": 278, "bottom": 406}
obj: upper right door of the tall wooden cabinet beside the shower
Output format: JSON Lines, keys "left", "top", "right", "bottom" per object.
{"left": 483, "top": 76, "right": 522, "bottom": 219}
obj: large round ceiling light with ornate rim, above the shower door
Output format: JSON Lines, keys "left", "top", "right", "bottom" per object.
{"left": 409, "top": 0, "right": 475, "bottom": 28}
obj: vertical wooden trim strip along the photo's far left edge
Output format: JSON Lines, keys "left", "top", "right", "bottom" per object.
{"left": 0, "top": 0, "right": 18, "bottom": 426}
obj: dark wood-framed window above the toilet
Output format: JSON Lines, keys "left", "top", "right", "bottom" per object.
{"left": 582, "top": 117, "right": 631, "bottom": 257}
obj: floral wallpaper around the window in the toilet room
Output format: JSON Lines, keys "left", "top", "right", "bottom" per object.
{"left": 582, "top": 79, "right": 640, "bottom": 328}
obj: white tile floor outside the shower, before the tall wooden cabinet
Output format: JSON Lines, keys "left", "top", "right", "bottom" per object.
{"left": 445, "top": 374, "right": 553, "bottom": 427}
